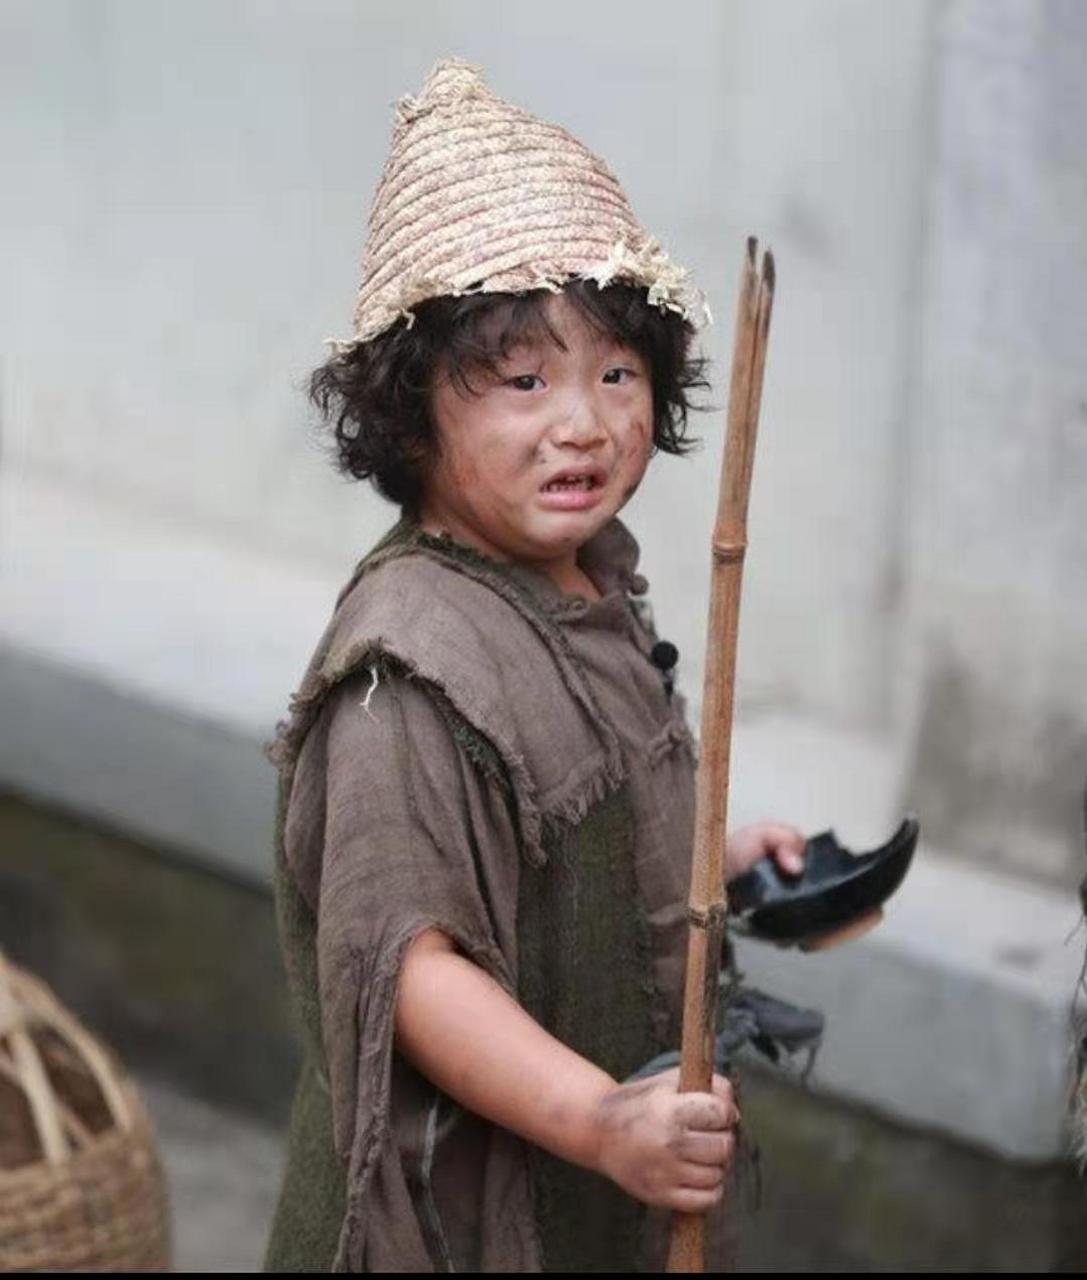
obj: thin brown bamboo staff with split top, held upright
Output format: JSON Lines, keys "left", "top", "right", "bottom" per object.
{"left": 668, "top": 237, "right": 775, "bottom": 1271}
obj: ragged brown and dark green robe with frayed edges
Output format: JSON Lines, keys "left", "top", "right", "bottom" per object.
{"left": 259, "top": 520, "right": 727, "bottom": 1271}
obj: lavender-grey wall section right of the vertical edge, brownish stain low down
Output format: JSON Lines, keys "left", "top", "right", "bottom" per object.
{"left": 903, "top": 0, "right": 1087, "bottom": 882}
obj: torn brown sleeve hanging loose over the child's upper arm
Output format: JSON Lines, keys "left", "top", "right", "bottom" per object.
{"left": 309, "top": 671, "right": 517, "bottom": 1270}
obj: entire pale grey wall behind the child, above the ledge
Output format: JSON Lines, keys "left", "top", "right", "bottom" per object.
{"left": 0, "top": 0, "right": 1087, "bottom": 882}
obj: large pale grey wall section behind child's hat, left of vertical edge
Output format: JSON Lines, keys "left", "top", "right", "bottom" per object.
{"left": 3, "top": 0, "right": 928, "bottom": 727}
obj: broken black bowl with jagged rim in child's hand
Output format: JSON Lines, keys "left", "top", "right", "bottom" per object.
{"left": 729, "top": 817, "right": 918, "bottom": 947}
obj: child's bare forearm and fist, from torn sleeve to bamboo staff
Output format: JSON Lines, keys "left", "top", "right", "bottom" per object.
{"left": 396, "top": 929, "right": 739, "bottom": 1213}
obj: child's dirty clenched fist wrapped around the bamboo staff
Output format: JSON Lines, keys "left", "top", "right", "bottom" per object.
{"left": 595, "top": 1068, "right": 740, "bottom": 1213}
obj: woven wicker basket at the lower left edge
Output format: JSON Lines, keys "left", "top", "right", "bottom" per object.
{"left": 0, "top": 952, "right": 169, "bottom": 1271}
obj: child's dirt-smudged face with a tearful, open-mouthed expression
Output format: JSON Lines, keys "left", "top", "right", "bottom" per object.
{"left": 421, "top": 294, "right": 653, "bottom": 573}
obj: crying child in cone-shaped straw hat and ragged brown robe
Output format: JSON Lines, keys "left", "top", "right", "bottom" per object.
{"left": 268, "top": 60, "right": 803, "bottom": 1271}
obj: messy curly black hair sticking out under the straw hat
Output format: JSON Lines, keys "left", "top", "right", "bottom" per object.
{"left": 309, "top": 279, "right": 709, "bottom": 512}
